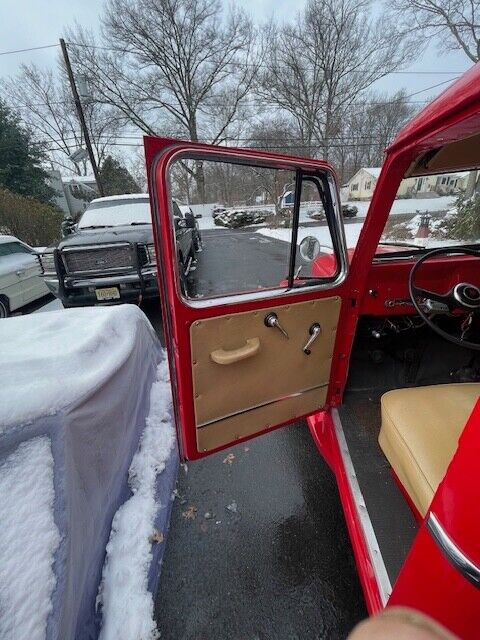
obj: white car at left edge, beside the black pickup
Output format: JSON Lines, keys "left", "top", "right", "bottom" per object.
{"left": 0, "top": 235, "right": 49, "bottom": 318}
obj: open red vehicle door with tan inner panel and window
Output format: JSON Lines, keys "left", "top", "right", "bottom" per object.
{"left": 145, "top": 138, "right": 348, "bottom": 459}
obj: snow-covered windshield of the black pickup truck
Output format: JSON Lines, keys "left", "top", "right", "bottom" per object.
{"left": 78, "top": 198, "right": 152, "bottom": 229}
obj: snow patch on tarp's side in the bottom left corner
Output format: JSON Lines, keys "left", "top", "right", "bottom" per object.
{"left": 0, "top": 436, "right": 60, "bottom": 640}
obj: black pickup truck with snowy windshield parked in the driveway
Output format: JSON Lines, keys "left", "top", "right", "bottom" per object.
{"left": 40, "top": 193, "right": 201, "bottom": 307}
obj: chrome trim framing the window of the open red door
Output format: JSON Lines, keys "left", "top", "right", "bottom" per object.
{"left": 165, "top": 147, "right": 349, "bottom": 309}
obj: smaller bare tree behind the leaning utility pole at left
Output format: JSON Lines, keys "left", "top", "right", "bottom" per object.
{"left": 2, "top": 61, "right": 119, "bottom": 175}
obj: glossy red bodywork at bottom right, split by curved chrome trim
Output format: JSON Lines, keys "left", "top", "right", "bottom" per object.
{"left": 389, "top": 401, "right": 480, "bottom": 640}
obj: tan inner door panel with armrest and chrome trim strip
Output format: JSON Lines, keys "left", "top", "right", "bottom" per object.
{"left": 190, "top": 297, "right": 341, "bottom": 451}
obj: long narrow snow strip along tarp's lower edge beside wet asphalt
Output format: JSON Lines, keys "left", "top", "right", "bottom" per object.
{"left": 98, "top": 361, "right": 175, "bottom": 640}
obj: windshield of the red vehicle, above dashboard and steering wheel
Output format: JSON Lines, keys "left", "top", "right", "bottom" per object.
{"left": 377, "top": 171, "right": 480, "bottom": 254}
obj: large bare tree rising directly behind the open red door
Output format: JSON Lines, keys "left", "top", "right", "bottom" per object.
{"left": 67, "top": 0, "right": 257, "bottom": 200}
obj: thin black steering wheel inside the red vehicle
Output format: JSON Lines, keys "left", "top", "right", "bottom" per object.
{"left": 408, "top": 247, "right": 480, "bottom": 351}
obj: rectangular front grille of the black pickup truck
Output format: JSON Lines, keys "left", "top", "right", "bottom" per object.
{"left": 63, "top": 244, "right": 135, "bottom": 273}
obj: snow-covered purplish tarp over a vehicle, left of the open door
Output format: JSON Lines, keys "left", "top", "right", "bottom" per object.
{"left": 0, "top": 305, "right": 176, "bottom": 640}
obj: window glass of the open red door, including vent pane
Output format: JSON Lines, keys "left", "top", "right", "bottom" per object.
{"left": 168, "top": 155, "right": 342, "bottom": 300}
